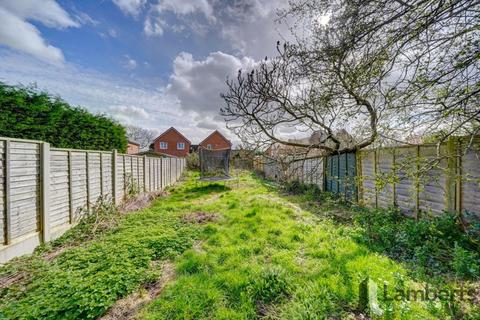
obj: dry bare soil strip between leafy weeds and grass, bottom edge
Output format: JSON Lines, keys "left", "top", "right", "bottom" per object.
{"left": 100, "top": 262, "right": 175, "bottom": 320}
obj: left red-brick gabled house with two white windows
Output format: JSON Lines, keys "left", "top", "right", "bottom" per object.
{"left": 152, "top": 127, "right": 191, "bottom": 157}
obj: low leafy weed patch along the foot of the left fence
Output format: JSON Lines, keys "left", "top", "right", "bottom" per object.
{"left": 0, "top": 185, "right": 196, "bottom": 319}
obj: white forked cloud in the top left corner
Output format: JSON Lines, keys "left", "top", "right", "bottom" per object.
{"left": 0, "top": 0, "right": 80, "bottom": 64}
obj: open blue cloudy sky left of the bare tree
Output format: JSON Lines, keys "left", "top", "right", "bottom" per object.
{"left": 0, "top": 0, "right": 289, "bottom": 143}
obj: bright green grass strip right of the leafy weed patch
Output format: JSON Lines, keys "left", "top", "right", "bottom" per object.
{"left": 139, "top": 175, "right": 473, "bottom": 320}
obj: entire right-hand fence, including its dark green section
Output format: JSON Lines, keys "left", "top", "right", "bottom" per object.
{"left": 255, "top": 139, "right": 480, "bottom": 222}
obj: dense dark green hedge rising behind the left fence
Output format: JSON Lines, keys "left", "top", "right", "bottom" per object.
{"left": 0, "top": 82, "right": 127, "bottom": 152}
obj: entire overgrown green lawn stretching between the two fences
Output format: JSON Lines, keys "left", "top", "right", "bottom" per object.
{"left": 0, "top": 173, "right": 474, "bottom": 319}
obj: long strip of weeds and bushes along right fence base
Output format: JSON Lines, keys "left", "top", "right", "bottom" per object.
{"left": 284, "top": 181, "right": 480, "bottom": 279}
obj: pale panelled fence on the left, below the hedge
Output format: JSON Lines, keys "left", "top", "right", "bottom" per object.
{"left": 0, "top": 137, "right": 186, "bottom": 263}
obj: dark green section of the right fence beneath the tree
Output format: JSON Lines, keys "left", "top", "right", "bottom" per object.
{"left": 325, "top": 152, "right": 357, "bottom": 201}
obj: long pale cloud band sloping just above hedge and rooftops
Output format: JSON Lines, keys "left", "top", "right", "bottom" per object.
{"left": 0, "top": 49, "right": 216, "bottom": 143}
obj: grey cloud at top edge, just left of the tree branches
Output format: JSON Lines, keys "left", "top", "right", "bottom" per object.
{"left": 144, "top": 0, "right": 291, "bottom": 59}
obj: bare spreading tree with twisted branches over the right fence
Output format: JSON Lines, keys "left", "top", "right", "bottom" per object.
{"left": 221, "top": 0, "right": 480, "bottom": 153}
